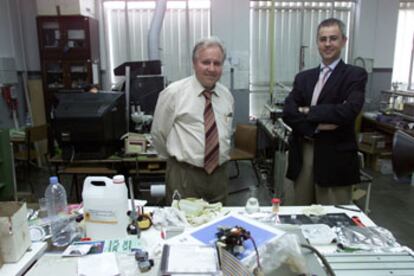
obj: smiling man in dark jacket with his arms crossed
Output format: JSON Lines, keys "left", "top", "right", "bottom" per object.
{"left": 283, "top": 18, "right": 367, "bottom": 205}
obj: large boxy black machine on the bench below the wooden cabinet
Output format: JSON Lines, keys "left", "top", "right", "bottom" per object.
{"left": 52, "top": 92, "right": 126, "bottom": 160}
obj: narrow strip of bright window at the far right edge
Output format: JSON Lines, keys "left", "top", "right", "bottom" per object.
{"left": 392, "top": 1, "right": 414, "bottom": 90}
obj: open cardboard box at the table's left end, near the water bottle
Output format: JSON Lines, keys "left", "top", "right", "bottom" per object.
{"left": 0, "top": 201, "right": 32, "bottom": 263}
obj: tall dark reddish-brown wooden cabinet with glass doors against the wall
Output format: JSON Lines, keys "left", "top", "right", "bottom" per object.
{"left": 37, "top": 15, "right": 99, "bottom": 117}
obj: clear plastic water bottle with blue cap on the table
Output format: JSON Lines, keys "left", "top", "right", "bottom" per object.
{"left": 45, "top": 176, "right": 72, "bottom": 247}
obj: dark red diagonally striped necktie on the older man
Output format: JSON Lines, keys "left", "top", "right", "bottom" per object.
{"left": 203, "top": 90, "right": 220, "bottom": 174}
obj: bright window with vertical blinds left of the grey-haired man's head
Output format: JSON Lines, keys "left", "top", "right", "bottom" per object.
{"left": 104, "top": 0, "right": 211, "bottom": 84}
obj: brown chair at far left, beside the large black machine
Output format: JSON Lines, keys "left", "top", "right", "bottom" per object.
{"left": 14, "top": 125, "right": 48, "bottom": 193}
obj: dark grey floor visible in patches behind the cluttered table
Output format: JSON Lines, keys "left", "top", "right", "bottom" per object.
{"left": 12, "top": 157, "right": 414, "bottom": 248}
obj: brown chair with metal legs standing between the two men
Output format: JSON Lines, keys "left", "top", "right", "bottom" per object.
{"left": 230, "top": 124, "right": 260, "bottom": 188}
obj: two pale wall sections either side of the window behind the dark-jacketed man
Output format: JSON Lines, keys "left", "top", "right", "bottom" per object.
{"left": 211, "top": 0, "right": 399, "bottom": 89}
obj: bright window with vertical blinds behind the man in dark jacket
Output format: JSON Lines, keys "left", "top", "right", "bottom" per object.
{"left": 250, "top": 0, "right": 355, "bottom": 115}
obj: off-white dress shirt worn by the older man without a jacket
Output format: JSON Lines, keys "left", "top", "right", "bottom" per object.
{"left": 151, "top": 75, "right": 234, "bottom": 167}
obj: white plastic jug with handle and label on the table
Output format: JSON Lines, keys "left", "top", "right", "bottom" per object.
{"left": 82, "top": 176, "right": 129, "bottom": 240}
